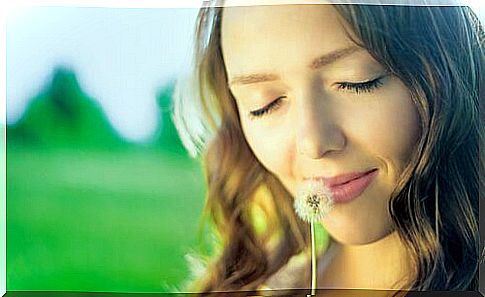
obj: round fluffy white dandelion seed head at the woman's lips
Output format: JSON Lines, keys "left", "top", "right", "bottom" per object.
{"left": 293, "top": 180, "right": 334, "bottom": 223}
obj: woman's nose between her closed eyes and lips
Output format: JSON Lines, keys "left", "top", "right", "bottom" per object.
{"left": 296, "top": 88, "right": 346, "bottom": 159}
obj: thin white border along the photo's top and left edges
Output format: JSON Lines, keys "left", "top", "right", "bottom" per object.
{"left": 0, "top": 0, "right": 485, "bottom": 296}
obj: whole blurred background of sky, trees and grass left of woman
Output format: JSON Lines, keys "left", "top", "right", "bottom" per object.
{"left": 6, "top": 6, "right": 205, "bottom": 292}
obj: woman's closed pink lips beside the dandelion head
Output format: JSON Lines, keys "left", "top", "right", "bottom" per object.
{"left": 306, "top": 169, "right": 377, "bottom": 203}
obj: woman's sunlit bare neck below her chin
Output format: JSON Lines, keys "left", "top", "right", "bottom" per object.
{"left": 318, "top": 232, "right": 411, "bottom": 290}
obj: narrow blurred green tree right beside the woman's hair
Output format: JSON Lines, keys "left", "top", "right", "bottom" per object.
{"left": 155, "top": 81, "right": 188, "bottom": 155}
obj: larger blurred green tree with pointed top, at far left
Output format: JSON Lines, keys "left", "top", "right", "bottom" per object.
{"left": 7, "top": 66, "right": 125, "bottom": 149}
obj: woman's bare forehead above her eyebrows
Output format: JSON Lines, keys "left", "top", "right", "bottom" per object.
{"left": 221, "top": 5, "right": 354, "bottom": 75}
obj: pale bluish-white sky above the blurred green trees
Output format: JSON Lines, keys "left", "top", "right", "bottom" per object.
{"left": 4, "top": 0, "right": 484, "bottom": 141}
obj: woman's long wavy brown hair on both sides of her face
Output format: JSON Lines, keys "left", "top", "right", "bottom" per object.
{"left": 174, "top": 1, "right": 485, "bottom": 291}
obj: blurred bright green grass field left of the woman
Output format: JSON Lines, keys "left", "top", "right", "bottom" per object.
{"left": 7, "top": 145, "right": 205, "bottom": 292}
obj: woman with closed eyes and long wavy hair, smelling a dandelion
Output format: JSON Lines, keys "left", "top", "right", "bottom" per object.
{"left": 174, "top": 1, "right": 484, "bottom": 291}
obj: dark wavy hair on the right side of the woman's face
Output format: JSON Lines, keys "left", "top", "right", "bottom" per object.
{"left": 330, "top": 5, "right": 484, "bottom": 290}
